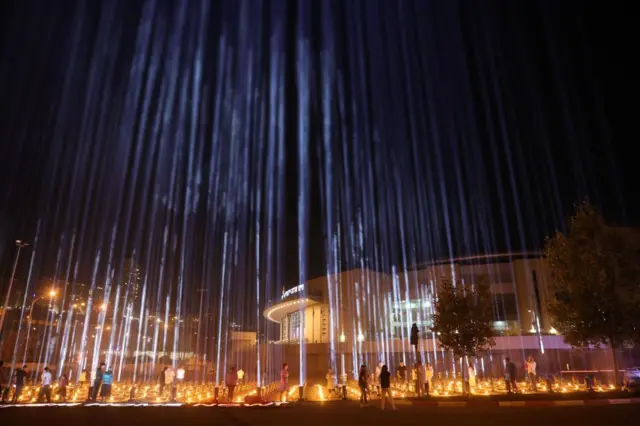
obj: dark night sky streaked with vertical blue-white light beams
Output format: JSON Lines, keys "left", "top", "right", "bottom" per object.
{"left": 0, "top": 0, "right": 639, "bottom": 326}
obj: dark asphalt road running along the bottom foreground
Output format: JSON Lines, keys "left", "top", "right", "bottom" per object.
{"left": 0, "top": 402, "right": 640, "bottom": 426}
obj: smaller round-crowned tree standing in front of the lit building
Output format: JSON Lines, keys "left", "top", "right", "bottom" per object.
{"left": 431, "top": 278, "right": 495, "bottom": 392}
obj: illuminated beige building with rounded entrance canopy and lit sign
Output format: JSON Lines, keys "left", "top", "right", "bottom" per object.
{"left": 264, "top": 253, "right": 608, "bottom": 375}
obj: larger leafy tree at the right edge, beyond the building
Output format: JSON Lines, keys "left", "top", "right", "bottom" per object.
{"left": 545, "top": 202, "right": 640, "bottom": 387}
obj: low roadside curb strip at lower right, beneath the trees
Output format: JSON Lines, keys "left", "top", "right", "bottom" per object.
{"left": 411, "top": 398, "right": 640, "bottom": 408}
